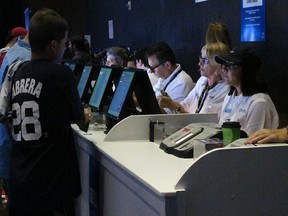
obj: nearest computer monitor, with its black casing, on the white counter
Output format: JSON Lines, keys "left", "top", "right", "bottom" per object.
{"left": 107, "top": 69, "right": 161, "bottom": 130}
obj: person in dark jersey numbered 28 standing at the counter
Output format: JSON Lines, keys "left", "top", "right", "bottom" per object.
{"left": 9, "top": 9, "right": 88, "bottom": 216}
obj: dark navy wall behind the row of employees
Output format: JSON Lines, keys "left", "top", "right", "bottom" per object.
{"left": 0, "top": 0, "right": 288, "bottom": 126}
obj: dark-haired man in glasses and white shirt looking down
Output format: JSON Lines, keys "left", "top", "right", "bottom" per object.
{"left": 147, "top": 42, "right": 195, "bottom": 113}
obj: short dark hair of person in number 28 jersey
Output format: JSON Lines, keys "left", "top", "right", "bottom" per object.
{"left": 29, "top": 8, "right": 68, "bottom": 52}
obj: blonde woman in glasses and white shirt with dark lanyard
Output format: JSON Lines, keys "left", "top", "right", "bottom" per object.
{"left": 160, "top": 42, "right": 230, "bottom": 116}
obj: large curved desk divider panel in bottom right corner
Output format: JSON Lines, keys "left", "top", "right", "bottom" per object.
{"left": 175, "top": 144, "right": 288, "bottom": 216}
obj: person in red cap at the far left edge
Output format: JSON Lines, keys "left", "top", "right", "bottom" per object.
{"left": 0, "top": 27, "right": 28, "bottom": 67}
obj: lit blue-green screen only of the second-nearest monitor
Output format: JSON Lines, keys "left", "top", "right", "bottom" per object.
{"left": 88, "top": 67, "right": 112, "bottom": 110}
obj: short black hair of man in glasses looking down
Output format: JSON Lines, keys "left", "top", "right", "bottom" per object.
{"left": 147, "top": 42, "right": 176, "bottom": 65}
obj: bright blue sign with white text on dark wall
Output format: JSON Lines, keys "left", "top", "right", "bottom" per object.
{"left": 241, "top": 0, "right": 266, "bottom": 42}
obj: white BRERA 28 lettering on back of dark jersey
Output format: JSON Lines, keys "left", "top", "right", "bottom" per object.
{"left": 12, "top": 78, "right": 43, "bottom": 141}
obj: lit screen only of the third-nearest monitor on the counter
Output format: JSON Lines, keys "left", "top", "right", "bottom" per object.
{"left": 77, "top": 65, "right": 93, "bottom": 100}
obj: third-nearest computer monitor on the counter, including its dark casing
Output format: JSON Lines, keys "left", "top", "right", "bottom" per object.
{"left": 77, "top": 65, "right": 98, "bottom": 103}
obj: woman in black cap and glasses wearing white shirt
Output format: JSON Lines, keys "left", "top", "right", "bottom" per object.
{"left": 215, "top": 47, "right": 279, "bottom": 135}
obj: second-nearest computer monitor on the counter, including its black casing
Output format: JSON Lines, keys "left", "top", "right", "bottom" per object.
{"left": 88, "top": 66, "right": 123, "bottom": 112}
